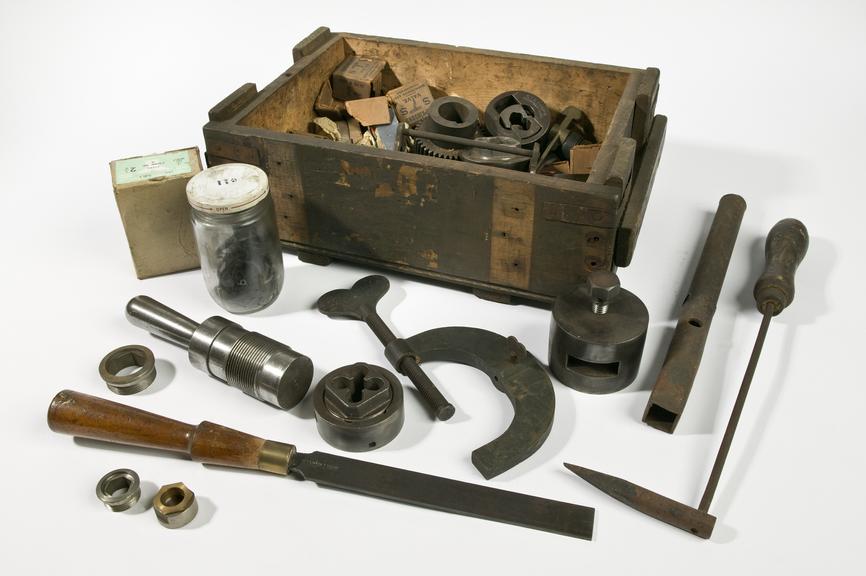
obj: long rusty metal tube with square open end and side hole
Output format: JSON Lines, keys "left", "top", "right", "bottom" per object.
{"left": 643, "top": 194, "right": 746, "bottom": 434}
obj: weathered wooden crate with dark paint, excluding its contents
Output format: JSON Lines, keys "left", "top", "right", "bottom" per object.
{"left": 204, "top": 28, "right": 666, "bottom": 303}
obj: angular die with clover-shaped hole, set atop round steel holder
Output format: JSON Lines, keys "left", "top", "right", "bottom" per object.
{"left": 325, "top": 364, "right": 392, "bottom": 420}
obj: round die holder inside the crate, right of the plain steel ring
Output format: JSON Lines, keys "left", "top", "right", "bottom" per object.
{"left": 484, "top": 90, "right": 551, "bottom": 148}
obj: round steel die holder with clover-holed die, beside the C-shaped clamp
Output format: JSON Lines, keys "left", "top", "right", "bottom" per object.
{"left": 313, "top": 363, "right": 404, "bottom": 452}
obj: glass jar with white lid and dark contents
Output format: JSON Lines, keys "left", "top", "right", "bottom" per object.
{"left": 186, "top": 164, "right": 283, "bottom": 314}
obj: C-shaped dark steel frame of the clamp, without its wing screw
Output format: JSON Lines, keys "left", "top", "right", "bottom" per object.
{"left": 406, "top": 326, "right": 556, "bottom": 480}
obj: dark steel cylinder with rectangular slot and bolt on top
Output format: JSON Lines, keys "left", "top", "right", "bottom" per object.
{"left": 549, "top": 270, "right": 649, "bottom": 394}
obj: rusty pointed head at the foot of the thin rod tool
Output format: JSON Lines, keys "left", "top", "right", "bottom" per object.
{"left": 565, "top": 463, "right": 716, "bottom": 540}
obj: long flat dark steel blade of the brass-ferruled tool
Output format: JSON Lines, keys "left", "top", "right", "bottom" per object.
{"left": 289, "top": 452, "right": 595, "bottom": 540}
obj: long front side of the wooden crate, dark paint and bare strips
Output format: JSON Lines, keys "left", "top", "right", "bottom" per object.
{"left": 205, "top": 124, "right": 619, "bottom": 300}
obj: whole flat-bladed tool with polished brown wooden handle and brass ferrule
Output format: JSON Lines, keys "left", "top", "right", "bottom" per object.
{"left": 48, "top": 390, "right": 595, "bottom": 540}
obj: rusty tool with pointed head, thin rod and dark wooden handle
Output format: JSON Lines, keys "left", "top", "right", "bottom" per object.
{"left": 565, "top": 218, "right": 809, "bottom": 538}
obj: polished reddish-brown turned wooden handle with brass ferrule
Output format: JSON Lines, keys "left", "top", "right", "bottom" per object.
{"left": 48, "top": 390, "right": 295, "bottom": 475}
